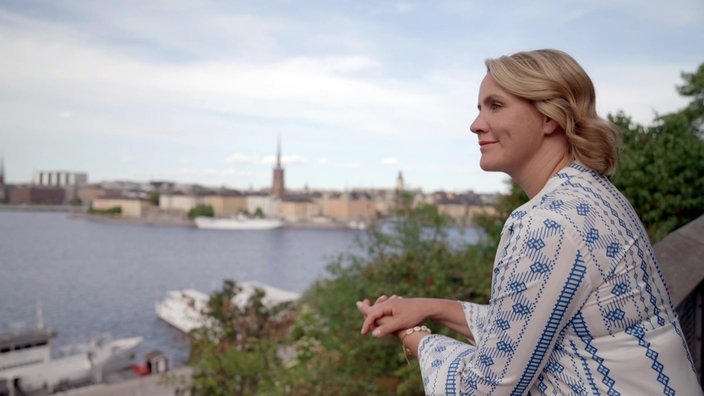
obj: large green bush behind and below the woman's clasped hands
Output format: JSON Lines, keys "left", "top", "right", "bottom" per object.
{"left": 280, "top": 204, "right": 494, "bottom": 395}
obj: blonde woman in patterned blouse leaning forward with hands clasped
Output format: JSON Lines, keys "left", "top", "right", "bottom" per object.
{"left": 357, "top": 50, "right": 702, "bottom": 395}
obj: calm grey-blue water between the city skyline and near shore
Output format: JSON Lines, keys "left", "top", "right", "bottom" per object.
{"left": 0, "top": 211, "right": 477, "bottom": 367}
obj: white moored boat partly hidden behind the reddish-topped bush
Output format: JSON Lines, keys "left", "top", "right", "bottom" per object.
{"left": 154, "top": 281, "right": 300, "bottom": 334}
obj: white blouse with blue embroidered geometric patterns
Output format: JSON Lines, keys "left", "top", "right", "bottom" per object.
{"left": 418, "top": 163, "right": 702, "bottom": 396}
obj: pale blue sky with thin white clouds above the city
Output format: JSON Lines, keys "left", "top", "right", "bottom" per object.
{"left": 0, "top": 0, "right": 704, "bottom": 193}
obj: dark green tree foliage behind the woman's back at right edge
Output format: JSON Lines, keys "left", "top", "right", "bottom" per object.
{"left": 610, "top": 64, "right": 704, "bottom": 243}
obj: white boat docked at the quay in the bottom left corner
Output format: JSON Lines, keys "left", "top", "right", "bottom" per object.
{"left": 0, "top": 328, "right": 142, "bottom": 394}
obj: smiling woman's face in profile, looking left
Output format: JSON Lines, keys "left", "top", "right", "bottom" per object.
{"left": 470, "top": 74, "right": 550, "bottom": 177}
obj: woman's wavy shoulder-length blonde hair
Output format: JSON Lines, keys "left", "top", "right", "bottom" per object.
{"left": 486, "top": 49, "right": 621, "bottom": 175}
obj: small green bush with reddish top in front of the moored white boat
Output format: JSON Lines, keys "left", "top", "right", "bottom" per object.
{"left": 189, "top": 280, "right": 292, "bottom": 396}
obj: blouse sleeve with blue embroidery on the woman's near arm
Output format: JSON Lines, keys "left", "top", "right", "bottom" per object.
{"left": 418, "top": 212, "right": 591, "bottom": 395}
